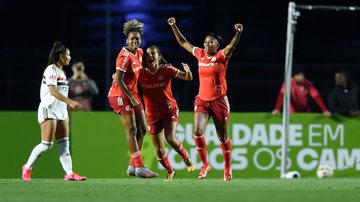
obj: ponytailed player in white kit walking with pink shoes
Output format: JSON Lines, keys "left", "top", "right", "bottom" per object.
{"left": 22, "top": 41, "right": 86, "bottom": 181}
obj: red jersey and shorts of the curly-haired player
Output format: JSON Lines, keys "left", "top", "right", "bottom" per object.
{"left": 108, "top": 47, "right": 143, "bottom": 113}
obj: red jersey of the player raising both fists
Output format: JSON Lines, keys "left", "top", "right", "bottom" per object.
{"left": 193, "top": 47, "right": 230, "bottom": 101}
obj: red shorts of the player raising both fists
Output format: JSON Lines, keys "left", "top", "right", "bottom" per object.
{"left": 194, "top": 95, "right": 230, "bottom": 124}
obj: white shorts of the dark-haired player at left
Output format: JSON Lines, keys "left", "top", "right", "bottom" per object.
{"left": 38, "top": 103, "right": 69, "bottom": 124}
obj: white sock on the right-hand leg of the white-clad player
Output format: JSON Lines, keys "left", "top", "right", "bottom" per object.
{"left": 57, "top": 137, "right": 73, "bottom": 175}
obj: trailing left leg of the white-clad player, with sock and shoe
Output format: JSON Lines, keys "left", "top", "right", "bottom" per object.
{"left": 22, "top": 119, "right": 56, "bottom": 181}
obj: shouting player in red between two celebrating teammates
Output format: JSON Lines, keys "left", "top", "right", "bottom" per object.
{"left": 139, "top": 45, "right": 195, "bottom": 181}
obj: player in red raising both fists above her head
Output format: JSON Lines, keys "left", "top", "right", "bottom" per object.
{"left": 168, "top": 17, "right": 243, "bottom": 181}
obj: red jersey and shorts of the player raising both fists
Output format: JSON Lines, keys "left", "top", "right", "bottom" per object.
{"left": 193, "top": 47, "right": 230, "bottom": 123}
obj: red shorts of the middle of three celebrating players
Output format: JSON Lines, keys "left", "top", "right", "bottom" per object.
{"left": 146, "top": 108, "right": 179, "bottom": 135}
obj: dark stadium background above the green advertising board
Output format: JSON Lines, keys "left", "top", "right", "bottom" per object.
{"left": 0, "top": 0, "right": 360, "bottom": 112}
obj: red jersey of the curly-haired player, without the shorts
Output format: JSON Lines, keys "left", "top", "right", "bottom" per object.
{"left": 108, "top": 47, "right": 143, "bottom": 97}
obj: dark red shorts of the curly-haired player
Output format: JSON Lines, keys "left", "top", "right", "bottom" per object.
{"left": 108, "top": 96, "right": 144, "bottom": 114}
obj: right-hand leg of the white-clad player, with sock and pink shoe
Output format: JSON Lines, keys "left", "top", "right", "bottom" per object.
{"left": 55, "top": 118, "right": 86, "bottom": 181}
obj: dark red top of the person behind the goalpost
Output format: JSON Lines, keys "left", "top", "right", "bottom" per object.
{"left": 275, "top": 78, "right": 327, "bottom": 113}
